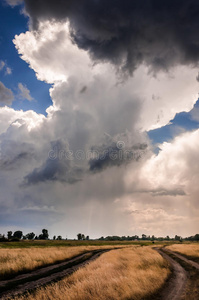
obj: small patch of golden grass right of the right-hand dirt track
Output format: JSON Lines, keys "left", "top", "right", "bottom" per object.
{"left": 167, "top": 243, "right": 199, "bottom": 258}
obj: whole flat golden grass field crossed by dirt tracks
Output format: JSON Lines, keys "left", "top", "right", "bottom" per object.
{"left": 0, "top": 240, "right": 199, "bottom": 300}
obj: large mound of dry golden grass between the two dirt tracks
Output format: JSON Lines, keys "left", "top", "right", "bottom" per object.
{"left": 16, "top": 247, "right": 170, "bottom": 300}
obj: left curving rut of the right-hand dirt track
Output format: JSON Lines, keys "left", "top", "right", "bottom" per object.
{"left": 154, "top": 248, "right": 188, "bottom": 300}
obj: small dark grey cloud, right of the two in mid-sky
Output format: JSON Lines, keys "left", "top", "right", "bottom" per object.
{"left": 89, "top": 141, "right": 147, "bottom": 172}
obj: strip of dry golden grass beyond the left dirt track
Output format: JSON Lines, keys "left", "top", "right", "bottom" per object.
{"left": 0, "top": 246, "right": 124, "bottom": 279}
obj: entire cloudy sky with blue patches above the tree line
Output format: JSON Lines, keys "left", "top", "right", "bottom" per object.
{"left": 0, "top": 0, "right": 199, "bottom": 238}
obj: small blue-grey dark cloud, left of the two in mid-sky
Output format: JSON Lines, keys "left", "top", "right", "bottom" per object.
{"left": 24, "top": 140, "right": 82, "bottom": 185}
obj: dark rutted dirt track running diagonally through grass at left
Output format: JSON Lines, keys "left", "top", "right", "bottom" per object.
{"left": 0, "top": 249, "right": 112, "bottom": 300}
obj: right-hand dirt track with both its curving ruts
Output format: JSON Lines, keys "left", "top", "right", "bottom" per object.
{"left": 154, "top": 248, "right": 199, "bottom": 300}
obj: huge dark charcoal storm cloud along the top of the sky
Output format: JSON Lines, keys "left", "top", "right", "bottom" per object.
{"left": 22, "top": 0, "right": 199, "bottom": 73}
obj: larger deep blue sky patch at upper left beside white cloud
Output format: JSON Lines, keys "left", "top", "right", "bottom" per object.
{"left": 0, "top": 2, "right": 52, "bottom": 115}
